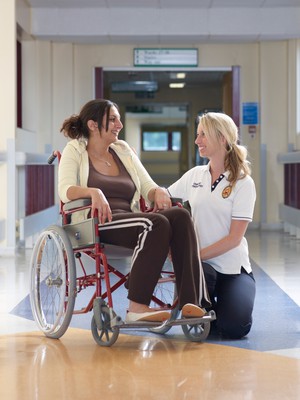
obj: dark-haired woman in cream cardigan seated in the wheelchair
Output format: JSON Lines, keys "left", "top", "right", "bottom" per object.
{"left": 58, "top": 99, "right": 209, "bottom": 322}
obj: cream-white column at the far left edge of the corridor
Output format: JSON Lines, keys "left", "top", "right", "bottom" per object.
{"left": 0, "top": 0, "right": 16, "bottom": 253}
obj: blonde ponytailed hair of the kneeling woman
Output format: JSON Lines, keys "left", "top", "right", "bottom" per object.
{"left": 199, "top": 112, "right": 251, "bottom": 185}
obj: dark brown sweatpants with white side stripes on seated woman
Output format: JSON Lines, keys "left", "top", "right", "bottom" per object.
{"left": 99, "top": 207, "right": 209, "bottom": 309}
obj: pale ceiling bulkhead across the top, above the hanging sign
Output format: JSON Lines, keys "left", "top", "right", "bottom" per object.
{"left": 25, "top": 0, "right": 300, "bottom": 46}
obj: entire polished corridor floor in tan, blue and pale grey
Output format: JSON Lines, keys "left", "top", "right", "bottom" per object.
{"left": 0, "top": 231, "right": 300, "bottom": 400}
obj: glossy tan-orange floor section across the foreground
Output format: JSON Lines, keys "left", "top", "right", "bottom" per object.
{"left": 0, "top": 328, "right": 300, "bottom": 400}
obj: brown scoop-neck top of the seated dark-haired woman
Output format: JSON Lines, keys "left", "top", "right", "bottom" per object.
{"left": 88, "top": 149, "right": 136, "bottom": 214}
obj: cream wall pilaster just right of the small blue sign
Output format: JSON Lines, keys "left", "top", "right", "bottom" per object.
{"left": 260, "top": 42, "right": 288, "bottom": 228}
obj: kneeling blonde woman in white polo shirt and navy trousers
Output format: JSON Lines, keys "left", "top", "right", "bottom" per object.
{"left": 169, "top": 113, "right": 256, "bottom": 338}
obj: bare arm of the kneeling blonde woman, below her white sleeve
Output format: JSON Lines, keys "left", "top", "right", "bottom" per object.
{"left": 200, "top": 219, "right": 249, "bottom": 261}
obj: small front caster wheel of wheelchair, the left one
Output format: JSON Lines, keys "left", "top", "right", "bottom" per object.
{"left": 91, "top": 309, "right": 119, "bottom": 347}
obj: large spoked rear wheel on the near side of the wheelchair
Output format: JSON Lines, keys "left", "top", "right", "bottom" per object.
{"left": 30, "top": 225, "right": 76, "bottom": 339}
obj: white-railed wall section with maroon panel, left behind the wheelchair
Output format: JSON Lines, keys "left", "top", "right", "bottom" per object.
{"left": 0, "top": 146, "right": 59, "bottom": 248}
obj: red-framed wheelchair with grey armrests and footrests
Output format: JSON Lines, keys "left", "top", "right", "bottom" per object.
{"left": 30, "top": 151, "right": 216, "bottom": 346}
